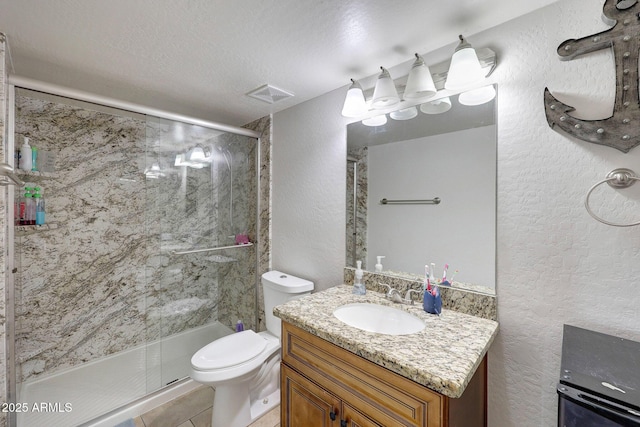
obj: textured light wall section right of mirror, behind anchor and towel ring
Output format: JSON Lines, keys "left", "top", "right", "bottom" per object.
{"left": 478, "top": 0, "right": 640, "bottom": 426}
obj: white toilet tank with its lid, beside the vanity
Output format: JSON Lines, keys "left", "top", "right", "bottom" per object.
{"left": 262, "top": 270, "right": 313, "bottom": 338}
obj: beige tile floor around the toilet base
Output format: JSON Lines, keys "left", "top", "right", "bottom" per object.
{"left": 133, "top": 385, "right": 280, "bottom": 427}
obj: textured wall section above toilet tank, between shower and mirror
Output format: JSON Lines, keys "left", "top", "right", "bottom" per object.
{"left": 272, "top": 90, "right": 347, "bottom": 290}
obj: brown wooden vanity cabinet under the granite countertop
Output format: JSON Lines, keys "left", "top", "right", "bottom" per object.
{"left": 281, "top": 322, "right": 487, "bottom": 427}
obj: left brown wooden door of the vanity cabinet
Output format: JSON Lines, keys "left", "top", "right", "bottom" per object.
{"left": 280, "top": 364, "right": 342, "bottom": 427}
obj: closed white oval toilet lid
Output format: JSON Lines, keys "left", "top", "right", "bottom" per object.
{"left": 191, "top": 329, "right": 267, "bottom": 370}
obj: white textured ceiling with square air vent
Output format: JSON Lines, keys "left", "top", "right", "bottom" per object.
{"left": 0, "top": 0, "right": 557, "bottom": 126}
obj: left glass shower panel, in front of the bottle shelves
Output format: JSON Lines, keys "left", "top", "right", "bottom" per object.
{"left": 13, "top": 89, "right": 153, "bottom": 427}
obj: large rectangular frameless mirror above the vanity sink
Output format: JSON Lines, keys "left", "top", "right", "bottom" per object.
{"left": 346, "top": 87, "right": 497, "bottom": 294}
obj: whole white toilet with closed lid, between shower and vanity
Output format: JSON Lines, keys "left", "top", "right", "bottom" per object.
{"left": 191, "top": 270, "right": 313, "bottom": 427}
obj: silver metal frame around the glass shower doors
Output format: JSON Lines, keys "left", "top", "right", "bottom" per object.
{"left": 4, "top": 75, "right": 262, "bottom": 427}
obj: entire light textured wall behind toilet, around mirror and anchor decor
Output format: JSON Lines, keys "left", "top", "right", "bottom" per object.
{"left": 273, "top": 0, "right": 640, "bottom": 427}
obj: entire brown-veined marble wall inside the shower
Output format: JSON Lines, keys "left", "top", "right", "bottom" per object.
{"left": 16, "top": 90, "right": 264, "bottom": 381}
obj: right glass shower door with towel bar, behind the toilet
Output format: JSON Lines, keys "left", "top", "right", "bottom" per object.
{"left": 145, "top": 117, "right": 257, "bottom": 391}
